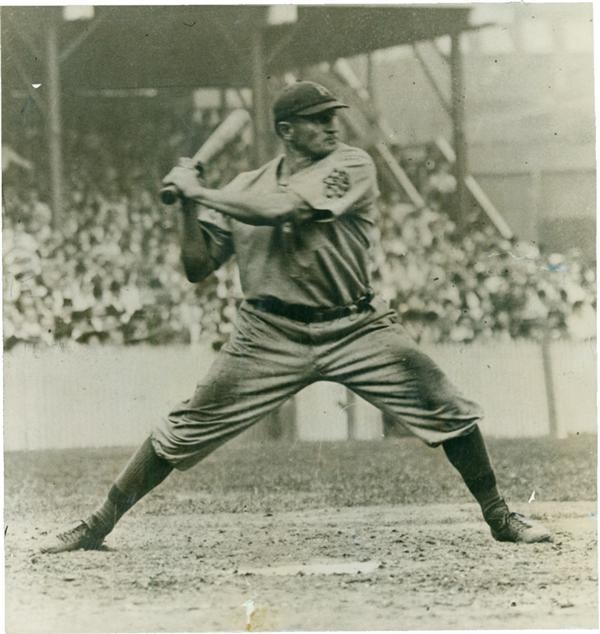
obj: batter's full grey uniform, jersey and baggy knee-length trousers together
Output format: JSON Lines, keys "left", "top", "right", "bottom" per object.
{"left": 152, "top": 144, "right": 481, "bottom": 469}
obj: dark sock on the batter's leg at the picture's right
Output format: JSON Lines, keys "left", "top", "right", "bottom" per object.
{"left": 442, "top": 427, "right": 506, "bottom": 519}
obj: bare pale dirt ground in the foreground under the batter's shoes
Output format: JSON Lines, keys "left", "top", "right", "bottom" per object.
{"left": 6, "top": 503, "right": 598, "bottom": 633}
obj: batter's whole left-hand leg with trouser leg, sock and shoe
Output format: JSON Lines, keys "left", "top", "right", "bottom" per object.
{"left": 42, "top": 304, "right": 314, "bottom": 552}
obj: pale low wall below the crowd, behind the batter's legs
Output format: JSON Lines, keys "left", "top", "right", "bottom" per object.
{"left": 4, "top": 342, "right": 596, "bottom": 450}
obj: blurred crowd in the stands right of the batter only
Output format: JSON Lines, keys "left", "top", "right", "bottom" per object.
{"left": 376, "top": 197, "right": 596, "bottom": 343}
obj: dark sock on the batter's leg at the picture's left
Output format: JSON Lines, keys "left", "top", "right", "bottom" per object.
{"left": 85, "top": 438, "right": 173, "bottom": 535}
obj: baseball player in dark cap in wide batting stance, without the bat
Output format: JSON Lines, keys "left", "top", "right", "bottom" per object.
{"left": 42, "top": 81, "right": 551, "bottom": 553}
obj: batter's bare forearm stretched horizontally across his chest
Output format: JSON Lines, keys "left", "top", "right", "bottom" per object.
{"left": 192, "top": 187, "right": 302, "bottom": 225}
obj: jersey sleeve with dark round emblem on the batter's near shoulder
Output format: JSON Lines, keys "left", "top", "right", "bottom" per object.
{"left": 289, "top": 148, "right": 379, "bottom": 220}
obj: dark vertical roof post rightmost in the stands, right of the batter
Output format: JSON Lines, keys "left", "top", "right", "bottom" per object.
{"left": 450, "top": 31, "right": 468, "bottom": 230}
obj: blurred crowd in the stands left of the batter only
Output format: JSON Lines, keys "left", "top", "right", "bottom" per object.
{"left": 3, "top": 105, "right": 248, "bottom": 348}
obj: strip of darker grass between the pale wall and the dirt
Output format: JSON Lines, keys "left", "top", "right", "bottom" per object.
{"left": 5, "top": 436, "right": 596, "bottom": 514}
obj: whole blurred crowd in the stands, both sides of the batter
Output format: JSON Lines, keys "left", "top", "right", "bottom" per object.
{"left": 3, "top": 105, "right": 596, "bottom": 348}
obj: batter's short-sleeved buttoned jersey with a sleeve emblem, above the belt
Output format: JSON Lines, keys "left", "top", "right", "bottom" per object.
{"left": 199, "top": 144, "right": 379, "bottom": 307}
